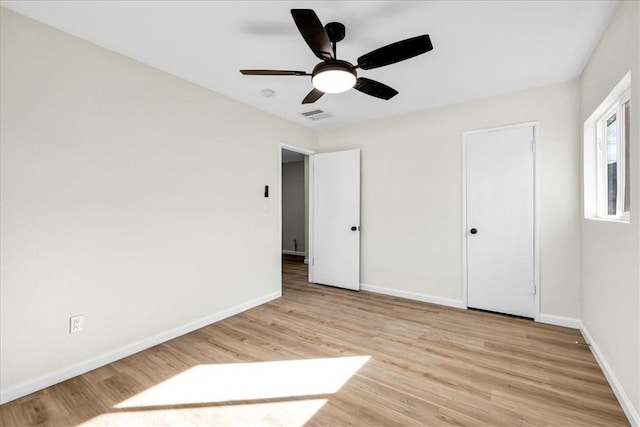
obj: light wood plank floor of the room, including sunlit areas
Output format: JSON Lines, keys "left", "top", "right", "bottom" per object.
{"left": 0, "top": 257, "right": 628, "bottom": 426}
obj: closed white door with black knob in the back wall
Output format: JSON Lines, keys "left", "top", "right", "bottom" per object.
{"left": 465, "top": 126, "right": 536, "bottom": 317}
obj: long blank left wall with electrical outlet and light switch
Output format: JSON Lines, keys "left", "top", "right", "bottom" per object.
{"left": 0, "top": 8, "right": 315, "bottom": 399}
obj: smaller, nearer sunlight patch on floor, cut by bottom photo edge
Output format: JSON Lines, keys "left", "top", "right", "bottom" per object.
{"left": 81, "top": 399, "right": 327, "bottom": 427}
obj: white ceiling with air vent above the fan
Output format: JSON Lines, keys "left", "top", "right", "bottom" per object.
{"left": 0, "top": 0, "right": 618, "bottom": 129}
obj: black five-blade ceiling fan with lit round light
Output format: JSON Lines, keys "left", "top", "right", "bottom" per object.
{"left": 240, "top": 9, "right": 433, "bottom": 104}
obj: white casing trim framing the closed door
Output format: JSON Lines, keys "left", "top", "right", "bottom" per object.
{"left": 461, "top": 121, "right": 541, "bottom": 321}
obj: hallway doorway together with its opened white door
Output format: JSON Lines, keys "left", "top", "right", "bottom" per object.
{"left": 278, "top": 144, "right": 360, "bottom": 290}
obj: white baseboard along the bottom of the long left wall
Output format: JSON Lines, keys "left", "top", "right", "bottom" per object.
{"left": 0, "top": 290, "right": 282, "bottom": 404}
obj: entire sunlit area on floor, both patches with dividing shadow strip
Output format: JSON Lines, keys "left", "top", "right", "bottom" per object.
{"left": 82, "top": 356, "right": 371, "bottom": 426}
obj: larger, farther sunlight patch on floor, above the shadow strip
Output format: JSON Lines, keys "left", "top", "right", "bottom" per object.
{"left": 115, "top": 356, "right": 370, "bottom": 409}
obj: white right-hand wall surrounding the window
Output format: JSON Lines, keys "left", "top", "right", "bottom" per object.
{"left": 580, "top": 1, "right": 640, "bottom": 423}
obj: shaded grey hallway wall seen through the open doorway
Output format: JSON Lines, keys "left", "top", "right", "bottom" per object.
{"left": 282, "top": 161, "right": 306, "bottom": 253}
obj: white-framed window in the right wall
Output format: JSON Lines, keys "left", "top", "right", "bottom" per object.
{"left": 596, "top": 91, "right": 631, "bottom": 221}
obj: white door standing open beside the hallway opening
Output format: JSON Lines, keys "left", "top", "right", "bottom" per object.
{"left": 311, "top": 150, "right": 360, "bottom": 290}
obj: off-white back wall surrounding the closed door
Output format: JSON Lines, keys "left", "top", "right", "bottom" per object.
{"left": 318, "top": 81, "right": 580, "bottom": 319}
